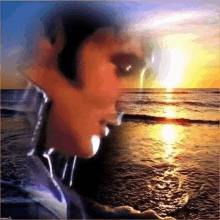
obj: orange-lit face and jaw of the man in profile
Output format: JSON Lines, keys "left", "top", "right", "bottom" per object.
{"left": 37, "top": 32, "right": 143, "bottom": 158}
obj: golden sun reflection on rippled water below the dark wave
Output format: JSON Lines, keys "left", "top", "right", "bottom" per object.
{"left": 111, "top": 122, "right": 191, "bottom": 213}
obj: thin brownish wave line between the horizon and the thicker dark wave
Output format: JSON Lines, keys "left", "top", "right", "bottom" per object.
{"left": 133, "top": 100, "right": 220, "bottom": 108}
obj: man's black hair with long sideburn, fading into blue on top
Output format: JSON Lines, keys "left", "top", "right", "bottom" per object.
{"left": 42, "top": 2, "right": 124, "bottom": 81}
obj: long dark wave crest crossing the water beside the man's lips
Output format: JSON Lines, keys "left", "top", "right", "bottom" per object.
{"left": 122, "top": 114, "right": 219, "bottom": 125}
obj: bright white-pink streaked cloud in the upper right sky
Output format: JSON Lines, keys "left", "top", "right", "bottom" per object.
{"left": 131, "top": 1, "right": 220, "bottom": 38}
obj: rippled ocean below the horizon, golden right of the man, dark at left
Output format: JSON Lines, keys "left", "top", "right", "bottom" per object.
{"left": 1, "top": 89, "right": 220, "bottom": 220}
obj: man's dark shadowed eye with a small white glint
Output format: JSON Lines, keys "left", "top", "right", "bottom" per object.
{"left": 111, "top": 53, "right": 145, "bottom": 77}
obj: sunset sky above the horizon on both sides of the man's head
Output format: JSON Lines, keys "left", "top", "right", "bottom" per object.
{"left": 1, "top": 0, "right": 220, "bottom": 89}
